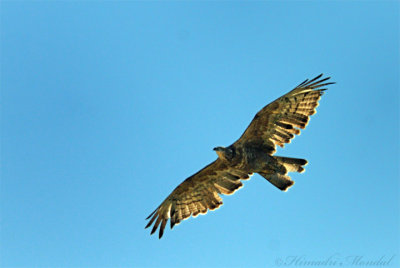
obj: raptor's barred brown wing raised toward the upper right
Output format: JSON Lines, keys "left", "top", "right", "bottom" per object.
{"left": 235, "top": 74, "right": 334, "bottom": 153}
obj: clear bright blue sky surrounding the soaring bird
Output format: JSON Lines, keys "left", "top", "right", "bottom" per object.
{"left": 0, "top": 1, "right": 400, "bottom": 267}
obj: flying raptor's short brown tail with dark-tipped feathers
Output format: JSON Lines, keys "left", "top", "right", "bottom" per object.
{"left": 258, "top": 156, "right": 308, "bottom": 191}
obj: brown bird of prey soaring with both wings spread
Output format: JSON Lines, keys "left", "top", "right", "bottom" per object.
{"left": 146, "top": 74, "right": 334, "bottom": 238}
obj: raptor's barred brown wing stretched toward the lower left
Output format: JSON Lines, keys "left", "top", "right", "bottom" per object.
{"left": 146, "top": 159, "right": 251, "bottom": 238}
